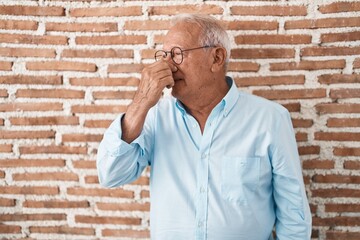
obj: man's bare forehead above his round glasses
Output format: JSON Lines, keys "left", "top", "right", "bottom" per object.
{"left": 164, "top": 22, "right": 200, "bottom": 49}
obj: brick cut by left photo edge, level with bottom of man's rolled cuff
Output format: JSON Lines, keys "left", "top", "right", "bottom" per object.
{"left": 0, "top": 130, "right": 55, "bottom": 139}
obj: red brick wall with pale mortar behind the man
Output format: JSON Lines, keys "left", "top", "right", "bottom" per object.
{"left": 0, "top": 0, "right": 360, "bottom": 240}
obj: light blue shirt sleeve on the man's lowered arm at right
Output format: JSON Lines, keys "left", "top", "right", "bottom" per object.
{"left": 271, "top": 111, "right": 311, "bottom": 240}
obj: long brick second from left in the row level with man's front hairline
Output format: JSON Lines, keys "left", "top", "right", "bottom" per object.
{"left": 45, "top": 22, "right": 118, "bottom": 32}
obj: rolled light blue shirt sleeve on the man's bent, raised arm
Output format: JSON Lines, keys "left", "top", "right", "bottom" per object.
{"left": 96, "top": 109, "right": 152, "bottom": 187}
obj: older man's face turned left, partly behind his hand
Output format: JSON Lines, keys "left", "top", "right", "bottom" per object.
{"left": 164, "top": 23, "right": 212, "bottom": 104}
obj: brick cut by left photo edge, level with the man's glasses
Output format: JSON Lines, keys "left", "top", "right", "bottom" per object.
{"left": 0, "top": 47, "right": 56, "bottom": 58}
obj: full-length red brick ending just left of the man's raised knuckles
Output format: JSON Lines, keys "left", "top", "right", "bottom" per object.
{"left": 70, "top": 77, "right": 139, "bottom": 86}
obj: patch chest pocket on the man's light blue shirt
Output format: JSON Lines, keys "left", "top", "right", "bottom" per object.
{"left": 221, "top": 156, "right": 260, "bottom": 205}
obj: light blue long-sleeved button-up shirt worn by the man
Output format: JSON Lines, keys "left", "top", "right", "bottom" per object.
{"left": 97, "top": 78, "right": 311, "bottom": 240}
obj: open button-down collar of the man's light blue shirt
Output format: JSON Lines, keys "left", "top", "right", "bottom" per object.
{"left": 175, "top": 77, "right": 239, "bottom": 117}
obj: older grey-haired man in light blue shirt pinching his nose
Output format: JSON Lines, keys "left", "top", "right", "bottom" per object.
{"left": 97, "top": 15, "right": 311, "bottom": 240}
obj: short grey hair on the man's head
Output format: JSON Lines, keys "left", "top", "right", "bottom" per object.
{"left": 171, "top": 13, "right": 230, "bottom": 68}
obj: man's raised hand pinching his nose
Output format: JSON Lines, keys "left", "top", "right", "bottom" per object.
{"left": 133, "top": 61, "right": 178, "bottom": 109}
